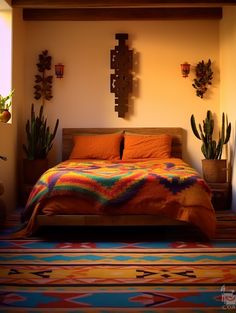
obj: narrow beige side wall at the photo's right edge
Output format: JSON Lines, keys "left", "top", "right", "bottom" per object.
{"left": 220, "top": 7, "right": 236, "bottom": 210}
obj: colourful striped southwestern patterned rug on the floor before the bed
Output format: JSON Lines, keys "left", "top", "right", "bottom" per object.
{"left": 0, "top": 211, "right": 236, "bottom": 313}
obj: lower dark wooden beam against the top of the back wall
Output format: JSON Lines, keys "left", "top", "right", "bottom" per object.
{"left": 23, "top": 8, "right": 222, "bottom": 21}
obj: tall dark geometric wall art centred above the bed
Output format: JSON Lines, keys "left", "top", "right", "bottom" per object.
{"left": 110, "top": 33, "right": 133, "bottom": 117}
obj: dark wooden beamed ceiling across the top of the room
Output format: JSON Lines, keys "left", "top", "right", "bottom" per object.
{"left": 8, "top": 0, "right": 236, "bottom": 21}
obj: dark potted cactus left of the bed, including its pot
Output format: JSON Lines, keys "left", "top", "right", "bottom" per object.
{"left": 23, "top": 104, "right": 59, "bottom": 184}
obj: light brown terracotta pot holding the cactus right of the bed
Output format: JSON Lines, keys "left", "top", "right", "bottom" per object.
{"left": 202, "top": 159, "right": 227, "bottom": 183}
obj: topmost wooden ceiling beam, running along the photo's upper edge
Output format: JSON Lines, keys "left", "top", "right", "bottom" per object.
{"left": 11, "top": 0, "right": 236, "bottom": 8}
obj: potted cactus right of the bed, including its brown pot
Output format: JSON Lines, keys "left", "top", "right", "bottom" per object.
{"left": 190, "top": 110, "right": 231, "bottom": 183}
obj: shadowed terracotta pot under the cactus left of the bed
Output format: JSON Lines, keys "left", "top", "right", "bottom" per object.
{"left": 23, "top": 159, "right": 48, "bottom": 185}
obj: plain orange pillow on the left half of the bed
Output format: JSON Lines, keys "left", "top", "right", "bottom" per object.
{"left": 70, "top": 133, "right": 123, "bottom": 160}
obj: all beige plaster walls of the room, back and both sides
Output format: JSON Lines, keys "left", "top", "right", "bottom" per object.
{"left": 0, "top": 7, "right": 233, "bottom": 210}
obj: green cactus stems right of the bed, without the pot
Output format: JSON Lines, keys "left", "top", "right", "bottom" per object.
{"left": 190, "top": 110, "right": 231, "bottom": 160}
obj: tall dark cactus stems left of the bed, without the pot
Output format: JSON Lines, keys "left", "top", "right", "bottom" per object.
{"left": 23, "top": 104, "right": 59, "bottom": 160}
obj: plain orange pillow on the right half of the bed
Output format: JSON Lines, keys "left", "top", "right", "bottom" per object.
{"left": 122, "top": 134, "right": 172, "bottom": 160}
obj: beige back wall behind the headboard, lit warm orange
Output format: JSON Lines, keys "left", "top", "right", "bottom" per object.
{"left": 24, "top": 21, "right": 219, "bottom": 170}
